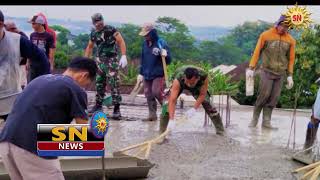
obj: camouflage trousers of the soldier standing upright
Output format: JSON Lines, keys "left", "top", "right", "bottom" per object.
{"left": 96, "top": 56, "right": 121, "bottom": 106}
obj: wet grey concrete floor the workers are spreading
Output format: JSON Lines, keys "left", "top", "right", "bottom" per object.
{"left": 88, "top": 92, "right": 310, "bottom": 180}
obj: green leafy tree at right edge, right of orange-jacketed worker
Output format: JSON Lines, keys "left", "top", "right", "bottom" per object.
{"left": 279, "top": 25, "right": 320, "bottom": 108}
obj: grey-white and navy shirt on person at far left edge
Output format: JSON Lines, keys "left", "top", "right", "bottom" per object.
{"left": 0, "top": 31, "right": 50, "bottom": 115}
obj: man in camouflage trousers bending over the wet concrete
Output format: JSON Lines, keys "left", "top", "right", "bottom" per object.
{"left": 160, "top": 65, "right": 224, "bottom": 135}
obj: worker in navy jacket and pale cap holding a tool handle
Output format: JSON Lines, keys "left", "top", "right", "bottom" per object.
{"left": 138, "top": 23, "right": 171, "bottom": 121}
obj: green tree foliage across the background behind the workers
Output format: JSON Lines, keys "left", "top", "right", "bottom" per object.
{"left": 52, "top": 17, "right": 320, "bottom": 107}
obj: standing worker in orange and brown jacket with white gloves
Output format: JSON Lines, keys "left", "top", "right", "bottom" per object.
{"left": 247, "top": 15, "right": 296, "bottom": 130}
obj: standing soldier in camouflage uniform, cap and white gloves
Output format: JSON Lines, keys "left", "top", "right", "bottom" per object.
{"left": 85, "top": 13, "right": 127, "bottom": 120}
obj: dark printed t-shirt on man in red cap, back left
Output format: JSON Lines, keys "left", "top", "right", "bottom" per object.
{"left": 30, "top": 31, "right": 55, "bottom": 58}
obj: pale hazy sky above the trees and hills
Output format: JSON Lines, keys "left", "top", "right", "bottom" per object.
{"left": 0, "top": 5, "right": 320, "bottom": 27}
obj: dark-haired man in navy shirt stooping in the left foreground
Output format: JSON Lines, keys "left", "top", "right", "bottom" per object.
{"left": 0, "top": 57, "right": 97, "bottom": 180}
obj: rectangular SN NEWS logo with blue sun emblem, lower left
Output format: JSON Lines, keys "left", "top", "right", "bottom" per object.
{"left": 37, "top": 111, "right": 109, "bottom": 156}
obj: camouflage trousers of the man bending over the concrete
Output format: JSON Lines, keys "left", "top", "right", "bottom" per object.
{"left": 160, "top": 90, "right": 224, "bottom": 133}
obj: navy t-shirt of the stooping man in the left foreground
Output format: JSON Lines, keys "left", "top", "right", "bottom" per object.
{"left": 0, "top": 74, "right": 87, "bottom": 159}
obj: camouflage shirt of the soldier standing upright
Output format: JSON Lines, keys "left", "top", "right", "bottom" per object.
{"left": 90, "top": 25, "right": 117, "bottom": 58}
